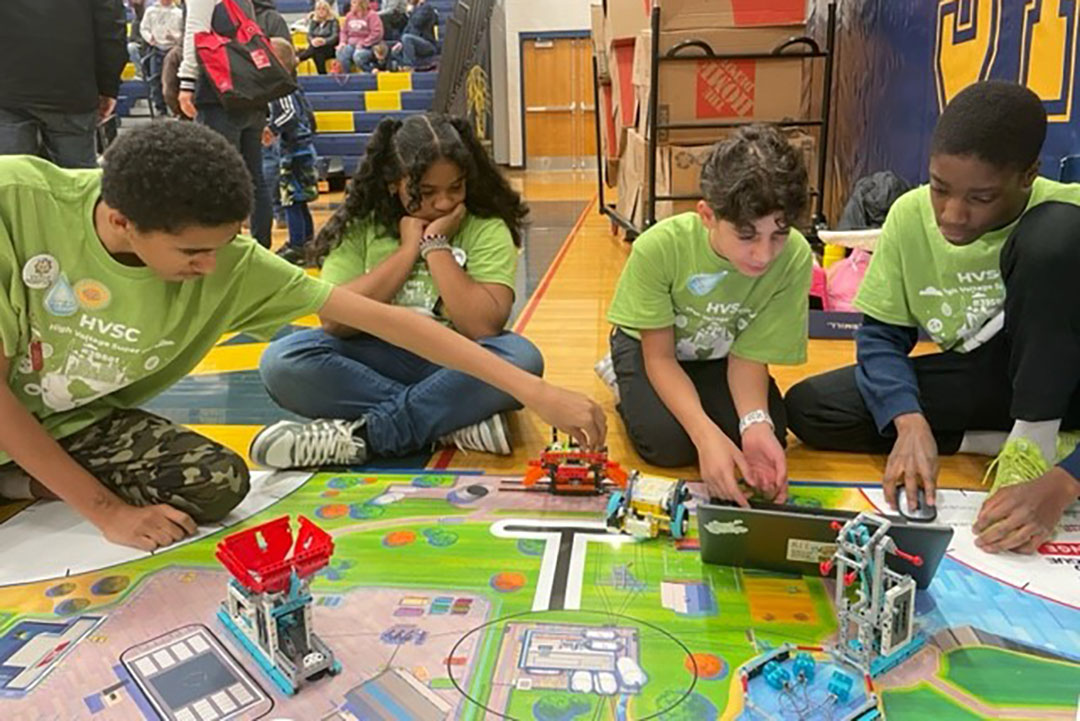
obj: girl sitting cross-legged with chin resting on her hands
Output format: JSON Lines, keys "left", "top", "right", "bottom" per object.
{"left": 253, "top": 114, "right": 543, "bottom": 467}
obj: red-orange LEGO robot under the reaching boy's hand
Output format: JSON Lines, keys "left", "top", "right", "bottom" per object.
{"left": 522, "top": 430, "right": 626, "bottom": 495}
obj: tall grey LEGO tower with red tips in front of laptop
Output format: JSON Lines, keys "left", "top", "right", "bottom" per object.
{"left": 821, "top": 513, "right": 926, "bottom": 678}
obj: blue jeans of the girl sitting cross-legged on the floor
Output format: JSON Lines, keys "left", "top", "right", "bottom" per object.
{"left": 259, "top": 329, "right": 543, "bottom": 457}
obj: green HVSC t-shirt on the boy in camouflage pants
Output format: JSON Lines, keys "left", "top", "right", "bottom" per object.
{"left": 0, "top": 157, "right": 330, "bottom": 464}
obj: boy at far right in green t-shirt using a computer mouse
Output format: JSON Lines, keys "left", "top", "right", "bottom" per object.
{"left": 786, "top": 81, "right": 1080, "bottom": 553}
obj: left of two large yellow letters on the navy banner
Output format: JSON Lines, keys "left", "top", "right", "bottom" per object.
{"left": 935, "top": 0, "right": 1001, "bottom": 109}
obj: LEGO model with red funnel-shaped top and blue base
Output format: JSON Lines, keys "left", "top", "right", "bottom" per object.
{"left": 216, "top": 516, "right": 341, "bottom": 695}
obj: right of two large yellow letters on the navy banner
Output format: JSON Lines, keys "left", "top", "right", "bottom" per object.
{"left": 1020, "top": 0, "right": 1080, "bottom": 123}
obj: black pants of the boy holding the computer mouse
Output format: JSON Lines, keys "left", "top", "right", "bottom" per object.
{"left": 785, "top": 203, "right": 1080, "bottom": 454}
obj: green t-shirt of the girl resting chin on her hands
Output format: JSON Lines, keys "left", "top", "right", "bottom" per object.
{"left": 322, "top": 209, "right": 517, "bottom": 324}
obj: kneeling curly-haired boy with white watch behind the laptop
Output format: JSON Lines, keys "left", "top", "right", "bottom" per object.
{"left": 608, "top": 125, "right": 813, "bottom": 505}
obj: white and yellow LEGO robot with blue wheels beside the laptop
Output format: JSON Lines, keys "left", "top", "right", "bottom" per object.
{"left": 607, "top": 471, "right": 690, "bottom": 540}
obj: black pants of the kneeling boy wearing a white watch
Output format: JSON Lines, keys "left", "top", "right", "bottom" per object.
{"left": 611, "top": 329, "right": 787, "bottom": 467}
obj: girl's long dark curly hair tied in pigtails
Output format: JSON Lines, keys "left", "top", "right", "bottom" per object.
{"left": 310, "top": 113, "right": 528, "bottom": 260}
